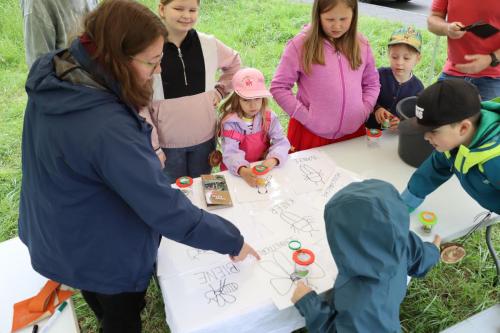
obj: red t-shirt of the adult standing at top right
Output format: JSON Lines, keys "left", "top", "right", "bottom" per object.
{"left": 432, "top": 0, "right": 500, "bottom": 78}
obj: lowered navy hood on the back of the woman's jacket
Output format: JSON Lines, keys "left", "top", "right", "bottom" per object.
{"left": 26, "top": 40, "right": 119, "bottom": 115}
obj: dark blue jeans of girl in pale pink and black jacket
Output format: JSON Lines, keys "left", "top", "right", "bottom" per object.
{"left": 162, "top": 139, "right": 215, "bottom": 183}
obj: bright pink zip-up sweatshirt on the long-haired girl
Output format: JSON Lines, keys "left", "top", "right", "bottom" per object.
{"left": 270, "top": 26, "right": 380, "bottom": 139}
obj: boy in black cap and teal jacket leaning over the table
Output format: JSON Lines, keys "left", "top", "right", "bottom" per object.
{"left": 402, "top": 79, "right": 500, "bottom": 214}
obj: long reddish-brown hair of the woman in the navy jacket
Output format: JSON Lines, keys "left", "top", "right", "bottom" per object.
{"left": 84, "top": 0, "right": 167, "bottom": 108}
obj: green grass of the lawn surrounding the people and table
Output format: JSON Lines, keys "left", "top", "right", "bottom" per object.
{"left": 0, "top": 0, "right": 500, "bottom": 333}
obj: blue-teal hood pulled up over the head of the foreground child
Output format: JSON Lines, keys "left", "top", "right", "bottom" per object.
{"left": 324, "top": 179, "right": 410, "bottom": 283}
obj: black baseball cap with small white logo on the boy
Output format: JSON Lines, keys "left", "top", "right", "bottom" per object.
{"left": 411, "top": 79, "right": 481, "bottom": 132}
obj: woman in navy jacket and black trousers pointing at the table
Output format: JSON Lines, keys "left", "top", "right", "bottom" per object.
{"left": 19, "top": 0, "right": 258, "bottom": 332}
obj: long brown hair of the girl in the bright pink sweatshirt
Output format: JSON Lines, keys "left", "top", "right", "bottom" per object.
{"left": 302, "top": 0, "right": 362, "bottom": 74}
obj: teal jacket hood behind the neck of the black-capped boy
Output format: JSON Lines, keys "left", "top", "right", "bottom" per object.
{"left": 470, "top": 101, "right": 500, "bottom": 147}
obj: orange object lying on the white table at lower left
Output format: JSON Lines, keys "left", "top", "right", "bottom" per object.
{"left": 12, "top": 280, "right": 74, "bottom": 332}
